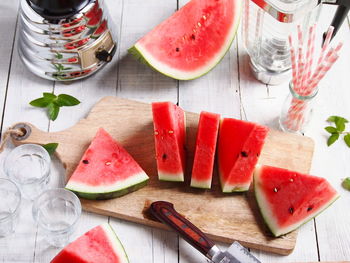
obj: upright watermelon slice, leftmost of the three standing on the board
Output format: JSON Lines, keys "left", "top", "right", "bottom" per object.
{"left": 152, "top": 102, "right": 186, "bottom": 182}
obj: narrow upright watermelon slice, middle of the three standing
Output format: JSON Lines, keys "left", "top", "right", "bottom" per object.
{"left": 191, "top": 111, "right": 220, "bottom": 189}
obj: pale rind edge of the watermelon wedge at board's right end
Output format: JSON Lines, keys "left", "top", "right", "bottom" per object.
{"left": 253, "top": 165, "right": 340, "bottom": 237}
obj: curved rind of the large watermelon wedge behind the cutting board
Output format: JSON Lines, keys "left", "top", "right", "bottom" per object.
{"left": 128, "top": 1, "right": 243, "bottom": 80}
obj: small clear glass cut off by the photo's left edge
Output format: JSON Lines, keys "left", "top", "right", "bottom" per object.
{"left": 0, "top": 178, "right": 21, "bottom": 237}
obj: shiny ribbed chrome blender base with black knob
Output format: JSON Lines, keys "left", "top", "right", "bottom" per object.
{"left": 18, "top": 0, "right": 116, "bottom": 81}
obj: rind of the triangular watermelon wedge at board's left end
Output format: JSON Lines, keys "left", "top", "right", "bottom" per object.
{"left": 65, "top": 172, "right": 149, "bottom": 200}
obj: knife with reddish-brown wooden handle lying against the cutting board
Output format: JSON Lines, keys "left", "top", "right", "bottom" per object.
{"left": 150, "top": 201, "right": 261, "bottom": 263}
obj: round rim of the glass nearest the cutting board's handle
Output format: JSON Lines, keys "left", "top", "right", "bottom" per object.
{"left": 3, "top": 143, "right": 51, "bottom": 185}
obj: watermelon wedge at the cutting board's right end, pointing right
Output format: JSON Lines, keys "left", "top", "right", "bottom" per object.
{"left": 254, "top": 166, "right": 339, "bottom": 237}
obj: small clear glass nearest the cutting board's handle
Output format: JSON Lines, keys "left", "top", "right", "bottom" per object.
{"left": 4, "top": 144, "right": 51, "bottom": 200}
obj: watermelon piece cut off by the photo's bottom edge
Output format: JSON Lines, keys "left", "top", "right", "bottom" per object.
{"left": 51, "top": 223, "right": 129, "bottom": 263}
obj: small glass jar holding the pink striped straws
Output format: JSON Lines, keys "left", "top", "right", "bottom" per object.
{"left": 279, "top": 81, "right": 318, "bottom": 134}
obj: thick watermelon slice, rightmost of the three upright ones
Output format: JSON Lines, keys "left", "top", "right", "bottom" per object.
{"left": 218, "top": 118, "right": 268, "bottom": 193}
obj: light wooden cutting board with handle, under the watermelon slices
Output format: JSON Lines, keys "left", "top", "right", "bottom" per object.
{"left": 10, "top": 97, "right": 314, "bottom": 254}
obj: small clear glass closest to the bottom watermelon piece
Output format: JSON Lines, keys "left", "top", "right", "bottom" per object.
{"left": 32, "top": 188, "right": 81, "bottom": 247}
